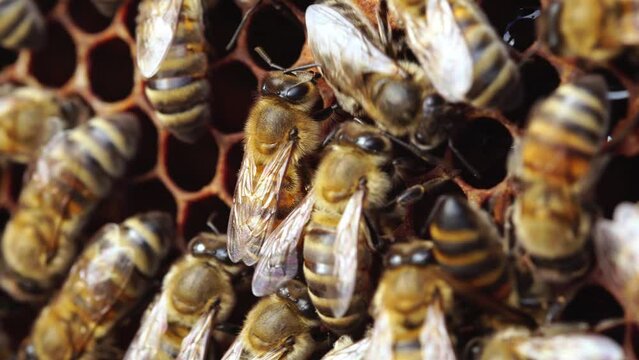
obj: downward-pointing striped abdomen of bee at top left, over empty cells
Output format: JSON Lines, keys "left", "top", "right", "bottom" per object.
{"left": 141, "top": 0, "right": 210, "bottom": 142}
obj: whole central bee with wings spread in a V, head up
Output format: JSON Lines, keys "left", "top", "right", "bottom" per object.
{"left": 253, "top": 122, "right": 400, "bottom": 334}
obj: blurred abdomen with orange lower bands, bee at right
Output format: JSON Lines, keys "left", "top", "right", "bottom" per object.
{"left": 519, "top": 76, "right": 608, "bottom": 190}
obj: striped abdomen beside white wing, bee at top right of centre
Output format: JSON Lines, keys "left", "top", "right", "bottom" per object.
{"left": 449, "top": 0, "right": 521, "bottom": 108}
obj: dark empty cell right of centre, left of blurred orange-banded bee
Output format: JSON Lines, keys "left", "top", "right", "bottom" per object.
{"left": 453, "top": 118, "right": 513, "bottom": 189}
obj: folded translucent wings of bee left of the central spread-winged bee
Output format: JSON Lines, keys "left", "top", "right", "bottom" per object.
{"left": 228, "top": 141, "right": 293, "bottom": 266}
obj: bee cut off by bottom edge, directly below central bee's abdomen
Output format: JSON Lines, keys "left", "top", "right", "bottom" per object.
{"left": 222, "top": 280, "right": 321, "bottom": 360}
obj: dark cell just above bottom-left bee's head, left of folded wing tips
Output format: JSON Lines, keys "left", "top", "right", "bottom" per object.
{"left": 184, "top": 196, "right": 230, "bottom": 241}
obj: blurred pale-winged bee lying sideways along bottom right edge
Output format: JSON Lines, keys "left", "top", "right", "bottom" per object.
{"left": 480, "top": 324, "right": 625, "bottom": 360}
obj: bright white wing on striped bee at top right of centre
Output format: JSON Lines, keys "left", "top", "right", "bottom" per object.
{"left": 403, "top": 0, "right": 473, "bottom": 102}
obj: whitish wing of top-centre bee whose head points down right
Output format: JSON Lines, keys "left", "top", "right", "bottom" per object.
{"left": 306, "top": 4, "right": 403, "bottom": 91}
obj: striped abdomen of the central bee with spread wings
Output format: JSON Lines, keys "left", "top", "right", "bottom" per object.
{"left": 304, "top": 209, "right": 372, "bottom": 334}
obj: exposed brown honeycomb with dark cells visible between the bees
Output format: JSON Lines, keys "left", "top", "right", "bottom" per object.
{"left": 0, "top": 0, "right": 639, "bottom": 359}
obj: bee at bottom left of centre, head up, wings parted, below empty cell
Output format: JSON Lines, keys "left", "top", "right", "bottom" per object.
{"left": 124, "top": 233, "right": 244, "bottom": 360}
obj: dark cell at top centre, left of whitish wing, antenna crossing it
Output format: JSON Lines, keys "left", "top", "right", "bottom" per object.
{"left": 248, "top": 6, "right": 304, "bottom": 70}
